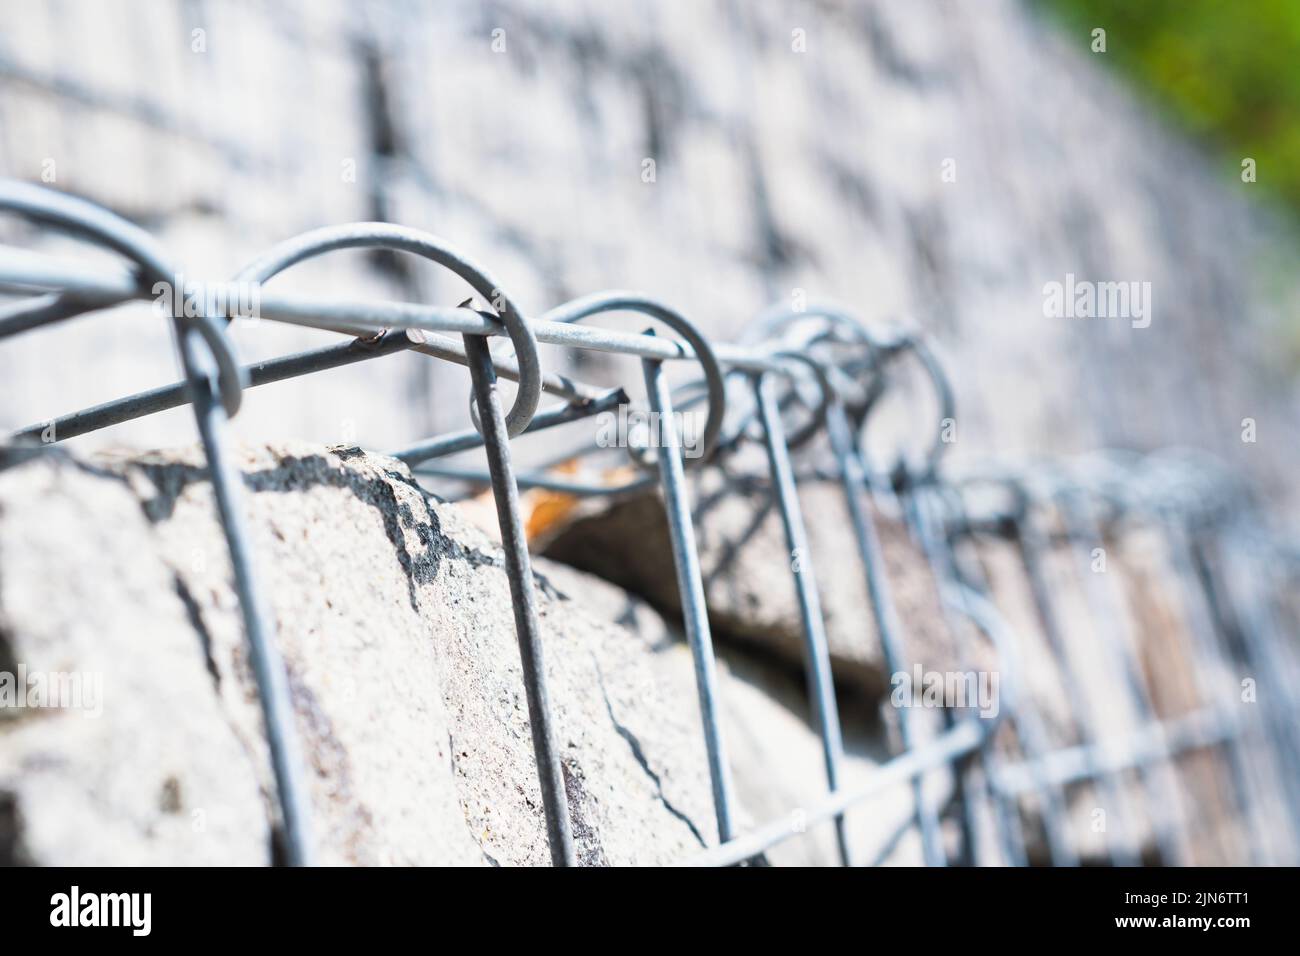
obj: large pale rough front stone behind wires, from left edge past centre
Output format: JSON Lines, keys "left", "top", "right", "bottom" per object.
{"left": 0, "top": 445, "right": 946, "bottom": 865}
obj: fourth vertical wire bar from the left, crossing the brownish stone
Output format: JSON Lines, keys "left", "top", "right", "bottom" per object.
{"left": 753, "top": 373, "right": 853, "bottom": 866}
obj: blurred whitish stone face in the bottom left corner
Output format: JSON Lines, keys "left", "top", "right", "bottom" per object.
{"left": 0, "top": 458, "right": 270, "bottom": 865}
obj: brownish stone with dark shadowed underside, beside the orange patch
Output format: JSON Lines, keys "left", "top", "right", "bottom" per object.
{"left": 546, "top": 467, "right": 952, "bottom": 696}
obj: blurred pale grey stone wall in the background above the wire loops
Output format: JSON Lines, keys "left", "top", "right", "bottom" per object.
{"left": 0, "top": 0, "right": 1300, "bottom": 509}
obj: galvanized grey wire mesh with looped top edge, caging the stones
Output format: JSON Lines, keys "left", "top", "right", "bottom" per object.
{"left": 0, "top": 182, "right": 1300, "bottom": 865}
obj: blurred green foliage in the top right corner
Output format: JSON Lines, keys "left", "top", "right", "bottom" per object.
{"left": 1037, "top": 0, "right": 1300, "bottom": 213}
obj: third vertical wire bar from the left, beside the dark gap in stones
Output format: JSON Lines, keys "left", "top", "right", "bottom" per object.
{"left": 641, "top": 359, "right": 736, "bottom": 843}
